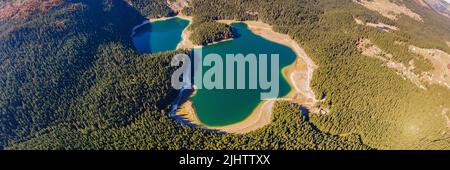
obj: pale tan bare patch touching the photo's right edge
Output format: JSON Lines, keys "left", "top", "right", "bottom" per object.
{"left": 409, "top": 45, "right": 450, "bottom": 88}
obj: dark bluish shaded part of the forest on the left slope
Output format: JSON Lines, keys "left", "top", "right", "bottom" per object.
{"left": 0, "top": 1, "right": 143, "bottom": 147}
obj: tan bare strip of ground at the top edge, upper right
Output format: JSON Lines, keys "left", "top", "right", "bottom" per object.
{"left": 353, "top": 0, "right": 423, "bottom": 22}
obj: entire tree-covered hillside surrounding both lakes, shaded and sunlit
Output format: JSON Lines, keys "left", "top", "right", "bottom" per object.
{"left": 0, "top": 0, "right": 450, "bottom": 150}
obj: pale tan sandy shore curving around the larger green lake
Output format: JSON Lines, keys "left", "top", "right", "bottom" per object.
{"left": 172, "top": 16, "right": 317, "bottom": 134}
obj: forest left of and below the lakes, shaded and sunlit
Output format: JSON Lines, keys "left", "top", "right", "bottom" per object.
{"left": 0, "top": 0, "right": 370, "bottom": 150}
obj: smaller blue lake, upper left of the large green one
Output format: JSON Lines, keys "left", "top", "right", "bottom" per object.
{"left": 133, "top": 18, "right": 189, "bottom": 54}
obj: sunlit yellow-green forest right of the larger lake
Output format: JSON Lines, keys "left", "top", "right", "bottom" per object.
{"left": 178, "top": 0, "right": 450, "bottom": 149}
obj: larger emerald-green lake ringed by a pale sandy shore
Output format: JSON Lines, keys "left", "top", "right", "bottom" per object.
{"left": 192, "top": 23, "right": 296, "bottom": 126}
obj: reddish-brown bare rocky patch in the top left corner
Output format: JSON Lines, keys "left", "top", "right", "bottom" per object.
{"left": 0, "top": 0, "right": 62, "bottom": 21}
